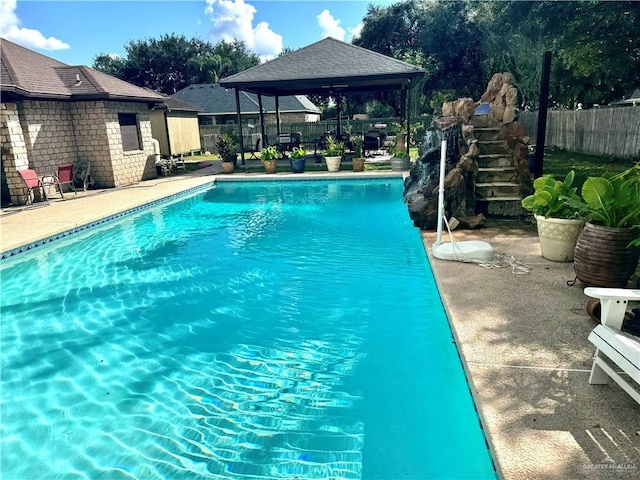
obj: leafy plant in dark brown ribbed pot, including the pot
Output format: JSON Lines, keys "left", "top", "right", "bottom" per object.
{"left": 573, "top": 165, "right": 640, "bottom": 287}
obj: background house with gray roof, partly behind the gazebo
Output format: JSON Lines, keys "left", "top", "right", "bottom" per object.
{"left": 171, "top": 83, "right": 320, "bottom": 125}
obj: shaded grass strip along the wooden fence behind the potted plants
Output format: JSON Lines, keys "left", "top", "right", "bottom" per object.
{"left": 542, "top": 150, "right": 633, "bottom": 187}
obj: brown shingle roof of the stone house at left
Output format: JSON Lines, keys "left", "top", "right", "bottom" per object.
{"left": 0, "top": 38, "right": 164, "bottom": 102}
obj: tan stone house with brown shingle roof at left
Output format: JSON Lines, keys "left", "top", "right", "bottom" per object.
{"left": 0, "top": 38, "right": 165, "bottom": 204}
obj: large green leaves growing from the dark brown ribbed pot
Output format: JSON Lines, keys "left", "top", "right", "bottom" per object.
{"left": 581, "top": 165, "right": 640, "bottom": 228}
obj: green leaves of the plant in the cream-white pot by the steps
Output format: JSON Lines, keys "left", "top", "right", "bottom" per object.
{"left": 522, "top": 170, "right": 583, "bottom": 218}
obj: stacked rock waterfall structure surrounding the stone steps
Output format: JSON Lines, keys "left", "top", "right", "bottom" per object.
{"left": 405, "top": 73, "right": 531, "bottom": 230}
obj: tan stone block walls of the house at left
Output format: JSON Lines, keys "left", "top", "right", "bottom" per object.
{"left": 0, "top": 100, "right": 156, "bottom": 204}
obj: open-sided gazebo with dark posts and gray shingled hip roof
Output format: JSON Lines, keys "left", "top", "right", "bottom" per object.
{"left": 220, "top": 37, "right": 425, "bottom": 162}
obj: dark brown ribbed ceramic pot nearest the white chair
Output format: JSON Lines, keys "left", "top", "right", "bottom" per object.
{"left": 573, "top": 223, "right": 640, "bottom": 288}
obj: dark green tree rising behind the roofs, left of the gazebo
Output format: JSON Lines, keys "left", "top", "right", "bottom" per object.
{"left": 93, "top": 34, "right": 260, "bottom": 95}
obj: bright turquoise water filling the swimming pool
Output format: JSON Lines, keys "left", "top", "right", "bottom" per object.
{"left": 0, "top": 179, "right": 496, "bottom": 480}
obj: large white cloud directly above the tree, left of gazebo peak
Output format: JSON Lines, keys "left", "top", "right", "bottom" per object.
{"left": 205, "top": 0, "right": 282, "bottom": 61}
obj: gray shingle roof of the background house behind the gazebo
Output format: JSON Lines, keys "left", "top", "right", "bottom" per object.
{"left": 170, "top": 83, "right": 320, "bottom": 115}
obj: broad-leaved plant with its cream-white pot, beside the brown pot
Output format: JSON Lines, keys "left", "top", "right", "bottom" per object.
{"left": 522, "top": 170, "right": 584, "bottom": 262}
